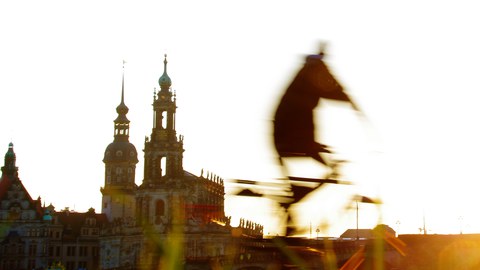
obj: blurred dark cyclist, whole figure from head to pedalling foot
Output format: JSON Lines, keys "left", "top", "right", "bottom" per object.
{"left": 273, "top": 44, "right": 359, "bottom": 236}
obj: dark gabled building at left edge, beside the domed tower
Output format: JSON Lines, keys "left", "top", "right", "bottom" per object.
{"left": 0, "top": 143, "right": 107, "bottom": 270}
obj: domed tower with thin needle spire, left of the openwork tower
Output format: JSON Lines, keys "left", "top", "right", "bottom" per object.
{"left": 100, "top": 62, "right": 138, "bottom": 221}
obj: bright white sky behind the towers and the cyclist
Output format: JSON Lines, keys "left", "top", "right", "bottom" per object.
{"left": 0, "top": 1, "right": 480, "bottom": 235}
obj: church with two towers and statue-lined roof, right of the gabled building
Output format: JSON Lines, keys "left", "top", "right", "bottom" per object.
{"left": 100, "top": 56, "right": 263, "bottom": 269}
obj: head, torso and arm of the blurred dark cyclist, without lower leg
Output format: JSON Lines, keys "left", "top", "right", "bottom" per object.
{"left": 273, "top": 44, "right": 359, "bottom": 171}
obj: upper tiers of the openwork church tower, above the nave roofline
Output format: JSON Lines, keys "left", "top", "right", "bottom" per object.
{"left": 143, "top": 55, "right": 184, "bottom": 187}
